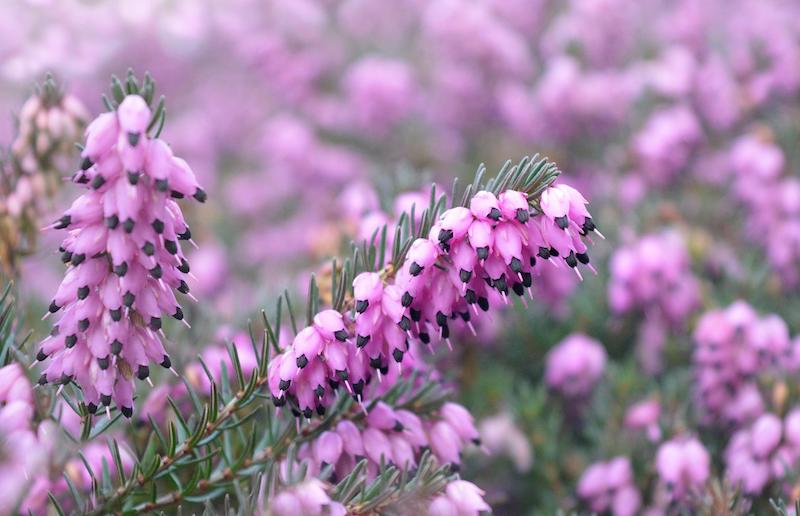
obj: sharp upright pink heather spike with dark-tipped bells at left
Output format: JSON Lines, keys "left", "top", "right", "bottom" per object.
{"left": 37, "top": 90, "right": 206, "bottom": 417}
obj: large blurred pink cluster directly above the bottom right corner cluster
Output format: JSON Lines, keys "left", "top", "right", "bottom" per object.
{"left": 692, "top": 301, "right": 797, "bottom": 426}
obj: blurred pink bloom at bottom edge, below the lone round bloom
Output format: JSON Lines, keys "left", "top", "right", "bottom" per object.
{"left": 578, "top": 457, "right": 642, "bottom": 516}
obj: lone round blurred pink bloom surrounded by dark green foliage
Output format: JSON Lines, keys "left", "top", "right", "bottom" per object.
{"left": 544, "top": 333, "right": 606, "bottom": 398}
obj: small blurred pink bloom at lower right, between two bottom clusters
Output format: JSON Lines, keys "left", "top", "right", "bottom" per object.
{"left": 656, "top": 437, "right": 711, "bottom": 501}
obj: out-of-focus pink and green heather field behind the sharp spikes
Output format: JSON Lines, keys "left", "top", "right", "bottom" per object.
{"left": 0, "top": 0, "right": 800, "bottom": 514}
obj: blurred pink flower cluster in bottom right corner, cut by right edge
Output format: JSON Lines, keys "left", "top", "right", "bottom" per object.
{"left": 725, "top": 409, "right": 800, "bottom": 495}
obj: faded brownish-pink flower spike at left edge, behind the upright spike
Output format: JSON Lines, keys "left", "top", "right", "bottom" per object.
{"left": 0, "top": 77, "right": 88, "bottom": 275}
